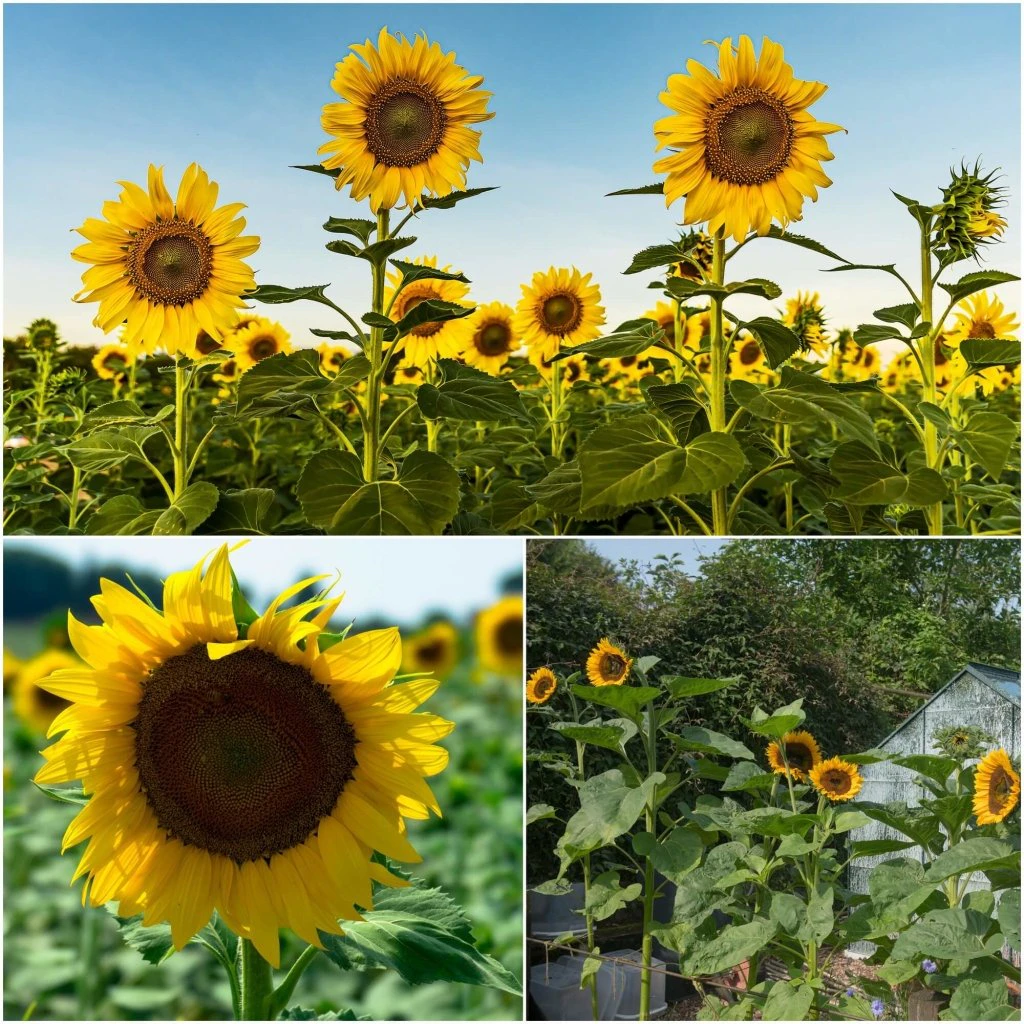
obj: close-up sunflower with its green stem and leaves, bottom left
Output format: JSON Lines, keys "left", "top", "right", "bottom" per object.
{"left": 29, "top": 546, "right": 520, "bottom": 1020}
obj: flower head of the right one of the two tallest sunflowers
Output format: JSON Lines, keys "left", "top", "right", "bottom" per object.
{"left": 654, "top": 36, "right": 843, "bottom": 242}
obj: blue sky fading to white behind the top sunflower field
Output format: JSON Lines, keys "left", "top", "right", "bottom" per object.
{"left": 3, "top": 3, "right": 1021, "bottom": 344}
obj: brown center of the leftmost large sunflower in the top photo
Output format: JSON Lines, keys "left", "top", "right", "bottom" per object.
{"left": 126, "top": 217, "right": 213, "bottom": 306}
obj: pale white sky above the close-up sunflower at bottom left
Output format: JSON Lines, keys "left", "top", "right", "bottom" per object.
{"left": 4, "top": 537, "right": 522, "bottom": 625}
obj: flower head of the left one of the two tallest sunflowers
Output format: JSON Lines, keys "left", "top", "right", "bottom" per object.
{"left": 318, "top": 29, "right": 494, "bottom": 212}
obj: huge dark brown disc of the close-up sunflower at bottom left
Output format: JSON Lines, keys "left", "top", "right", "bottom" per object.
{"left": 131, "top": 644, "right": 356, "bottom": 863}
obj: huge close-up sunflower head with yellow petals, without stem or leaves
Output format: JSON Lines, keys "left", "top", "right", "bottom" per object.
{"left": 36, "top": 546, "right": 452, "bottom": 967}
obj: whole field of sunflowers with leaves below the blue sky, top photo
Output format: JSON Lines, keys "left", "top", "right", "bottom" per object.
{"left": 4, "top": 30, "right": 1020, "bottom": 536}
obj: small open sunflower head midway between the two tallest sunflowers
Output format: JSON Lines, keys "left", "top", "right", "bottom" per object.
{"left": 513, "top": 267, "right": 604, "bottom": 359}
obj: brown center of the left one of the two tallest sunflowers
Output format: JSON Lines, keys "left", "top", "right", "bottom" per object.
{"left": 365, "top": 78, "right": 447, "bottom": 167}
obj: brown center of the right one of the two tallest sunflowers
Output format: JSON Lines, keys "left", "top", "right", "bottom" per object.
{"left": 705, "top": 85, "right": 794, "bottom": 185}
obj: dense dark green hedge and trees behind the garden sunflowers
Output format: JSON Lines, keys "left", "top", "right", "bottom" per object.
{"left": 526, "top": 541, "right": 1020, "bottom": 884}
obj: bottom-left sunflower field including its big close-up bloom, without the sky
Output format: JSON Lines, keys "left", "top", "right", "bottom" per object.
{"left": 4, "top": 548, "right": 522, "bottom": 1020}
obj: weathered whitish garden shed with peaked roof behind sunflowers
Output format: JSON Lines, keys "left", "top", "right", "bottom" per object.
{"left": 850, "top": 662, "right": 1021, "bottom": 917}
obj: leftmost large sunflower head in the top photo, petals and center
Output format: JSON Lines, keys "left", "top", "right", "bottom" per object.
{"left": 72, "top": 164, "right": 259, "bottom": 355}
